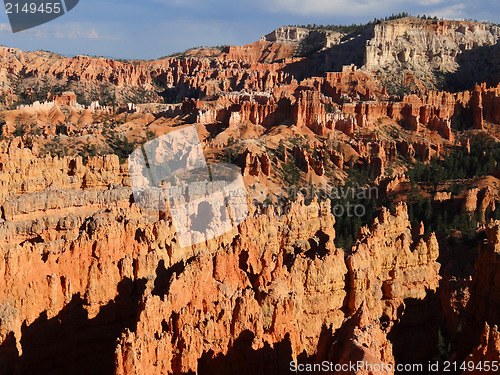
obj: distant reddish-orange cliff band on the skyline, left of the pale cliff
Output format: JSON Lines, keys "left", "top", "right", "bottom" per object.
{"left": 0, "top": 47, "right": 293, "bottom": 103}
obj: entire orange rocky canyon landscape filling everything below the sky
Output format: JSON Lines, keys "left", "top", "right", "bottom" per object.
{"left": 0, "top": 17, "right": 500, "bottom": 375}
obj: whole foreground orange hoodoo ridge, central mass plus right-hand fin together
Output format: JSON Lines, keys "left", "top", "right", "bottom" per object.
{"left": 116, "top": 202, "right": 439, "bottom": 374}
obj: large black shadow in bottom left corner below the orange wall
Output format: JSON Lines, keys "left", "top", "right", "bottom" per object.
{"left": 0, "top": 279, "right": 146, "bottom": 375}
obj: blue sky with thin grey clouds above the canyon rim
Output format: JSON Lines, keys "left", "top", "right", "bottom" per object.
{"left": 0, "top": 0, "right": 500, "bottom": 59}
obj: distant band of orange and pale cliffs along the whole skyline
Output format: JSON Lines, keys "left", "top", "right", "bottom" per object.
{"left": 0, "top": 17, "right": 500, "bottom": 110}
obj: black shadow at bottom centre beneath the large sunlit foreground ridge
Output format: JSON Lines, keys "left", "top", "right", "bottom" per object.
{"left": 198, "top": 331, "right": 292, "bottom": 375}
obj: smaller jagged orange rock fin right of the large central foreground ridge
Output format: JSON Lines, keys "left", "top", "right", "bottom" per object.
{"left": 347, "top": 205, "right": 439, "bottom": 320}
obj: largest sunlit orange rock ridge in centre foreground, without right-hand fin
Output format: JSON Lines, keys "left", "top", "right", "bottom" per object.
{"left": 116, "top": 198, "right": 347, "bottom": 374}
